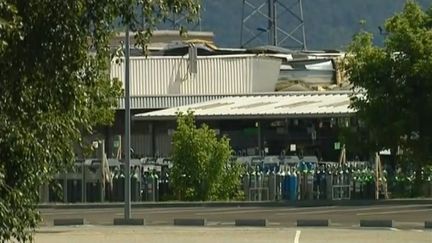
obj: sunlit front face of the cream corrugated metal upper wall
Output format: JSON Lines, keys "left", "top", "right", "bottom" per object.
{"left": 111, "top": 56, "right": 264, "bottom": 96}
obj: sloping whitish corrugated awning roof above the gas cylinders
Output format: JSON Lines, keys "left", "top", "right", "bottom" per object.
{"left": 134, "top": 92, "right": 355, "bottom": 120}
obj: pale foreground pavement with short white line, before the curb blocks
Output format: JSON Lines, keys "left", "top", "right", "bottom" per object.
{"left": 35, "top": 226, "right": 432, "bottom": 243}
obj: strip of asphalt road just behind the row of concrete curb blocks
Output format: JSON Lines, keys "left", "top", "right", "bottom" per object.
{"left": 40, "top": 204, "right": 432, "bottom": 229}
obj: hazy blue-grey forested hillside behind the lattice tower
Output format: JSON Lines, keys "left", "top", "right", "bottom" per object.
{"left": 201, "top": 0, "right": 432, "bottom": 49}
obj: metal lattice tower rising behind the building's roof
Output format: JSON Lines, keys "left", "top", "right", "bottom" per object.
{"left": 240, "top": 0, "right": 306, "bottom": 50}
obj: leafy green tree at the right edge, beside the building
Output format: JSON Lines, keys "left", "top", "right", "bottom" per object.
{"left": 346, "top": 1, "right": 432, "bottom": 188}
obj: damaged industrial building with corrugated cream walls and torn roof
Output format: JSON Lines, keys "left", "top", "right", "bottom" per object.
{"left": 102, "top": 30, "right": 353, "bottom": 163}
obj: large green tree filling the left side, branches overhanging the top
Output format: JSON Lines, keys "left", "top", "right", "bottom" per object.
{"left": 0, "top": 0, "right": 199, "bottom": 242}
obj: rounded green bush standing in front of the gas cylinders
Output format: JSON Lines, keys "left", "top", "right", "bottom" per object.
{"left": 171, "top": 112, "right": 241, "bottom": 201}
